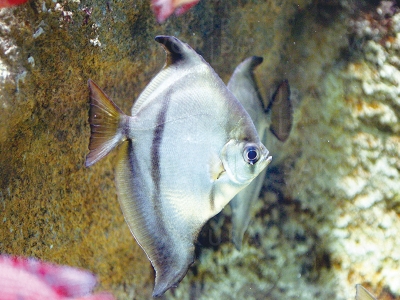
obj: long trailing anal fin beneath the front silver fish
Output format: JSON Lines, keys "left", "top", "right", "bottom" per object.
{"left": 115, "top": 139, "right": 197, "bottom": 297}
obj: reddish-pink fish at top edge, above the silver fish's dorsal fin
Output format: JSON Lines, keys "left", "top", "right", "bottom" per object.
{"left": 151, "top": 0, "right": 200, "bottom": 24}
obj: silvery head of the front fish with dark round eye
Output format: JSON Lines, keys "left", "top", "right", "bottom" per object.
{"left": 221, "top": 139, "right": 272, "bottom": 188}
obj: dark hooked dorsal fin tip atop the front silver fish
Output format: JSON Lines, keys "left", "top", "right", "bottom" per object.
{"left": 155, "top": 35, "right": 199, "bottom": 66}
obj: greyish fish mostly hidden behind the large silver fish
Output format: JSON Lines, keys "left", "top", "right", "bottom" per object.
{"left": 227, "top": 56, "right": 293, "bottom": 250}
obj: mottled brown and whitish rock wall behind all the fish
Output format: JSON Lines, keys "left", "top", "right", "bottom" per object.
{"left": 0, "top": 0, "right": 400, "bottom": 299}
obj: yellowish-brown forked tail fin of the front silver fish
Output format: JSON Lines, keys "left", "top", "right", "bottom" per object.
{"left": 85, "top": 79, "right": 127, "bottom": 167}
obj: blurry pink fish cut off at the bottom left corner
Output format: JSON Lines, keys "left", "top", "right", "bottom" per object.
{"left": 0, "top": 254, "right": 115, "bottom": 300}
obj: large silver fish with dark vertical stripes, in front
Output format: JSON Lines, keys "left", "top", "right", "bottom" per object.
{"left": 86, "top": 36, "right": 272, "bottom": 297}
